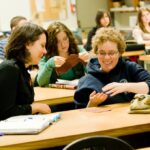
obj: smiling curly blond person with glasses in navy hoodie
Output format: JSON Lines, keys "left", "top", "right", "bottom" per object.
{"left": 74, "top": 27, "right": 150, "bottom": 108}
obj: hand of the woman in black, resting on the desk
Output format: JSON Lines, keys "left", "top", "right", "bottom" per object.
{"left": 31, "top": 103, "right": 51, "bottom": 114}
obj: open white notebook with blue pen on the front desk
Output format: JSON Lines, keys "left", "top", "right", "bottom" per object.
{"left": 0, "top": 113, "right": 60, "bottom": 134}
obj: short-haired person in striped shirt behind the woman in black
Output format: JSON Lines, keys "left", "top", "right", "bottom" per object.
{"left": 0, "top": 16, "right": 27, "bottom": 60}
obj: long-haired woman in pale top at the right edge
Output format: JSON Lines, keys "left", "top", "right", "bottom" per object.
{"left": 132, "top": 8, "right": 150, "bottom": 49}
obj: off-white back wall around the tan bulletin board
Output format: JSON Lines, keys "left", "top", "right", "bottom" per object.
{"left": 0, "top": 0, "right": 78, "bottom": 31}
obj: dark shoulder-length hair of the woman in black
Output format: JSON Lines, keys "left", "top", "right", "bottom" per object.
{"left": 5, "top": 23, "right": 47, "bottom": 64}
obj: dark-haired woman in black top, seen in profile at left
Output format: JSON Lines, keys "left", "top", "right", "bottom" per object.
{"left": 0, "top": 23, "right": 51, "bottom": 120}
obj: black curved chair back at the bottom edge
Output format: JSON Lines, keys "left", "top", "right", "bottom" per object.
{"left": 63, "top": 136, "right": 134, "bottom": 150}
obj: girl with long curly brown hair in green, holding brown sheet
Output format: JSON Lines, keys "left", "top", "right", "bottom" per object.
{"left": 36, "top": 22, "right": 89, "bottom": 86}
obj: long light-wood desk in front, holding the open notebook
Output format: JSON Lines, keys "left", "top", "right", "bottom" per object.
{"left": 0, "top": 103, "right": 150, "bottom": 150}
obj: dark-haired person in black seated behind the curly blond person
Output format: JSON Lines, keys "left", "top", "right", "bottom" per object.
{"left": 84, "top": 10, "right": 111, "bottom": 51}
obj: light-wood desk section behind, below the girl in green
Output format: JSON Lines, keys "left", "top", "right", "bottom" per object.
{"left": 34, "top": 87, "right": 75, "bottom": 105}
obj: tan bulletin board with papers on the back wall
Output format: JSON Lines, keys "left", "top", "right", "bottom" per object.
{"left": 30, "top": 0, "right": 68, "bottom": 21}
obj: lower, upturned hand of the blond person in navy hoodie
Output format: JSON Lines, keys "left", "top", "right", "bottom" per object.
{"left": 87, "top": 91, "right": 108, "bottom": 107}
